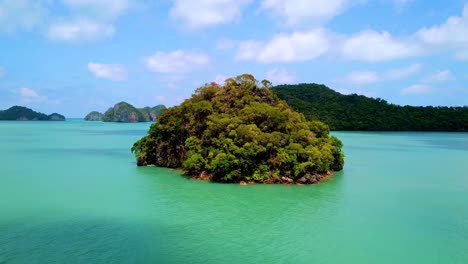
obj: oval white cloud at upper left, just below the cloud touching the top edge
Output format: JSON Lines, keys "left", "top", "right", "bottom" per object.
{"left": 48, "top": 19, "right": 115, "bottom": 42}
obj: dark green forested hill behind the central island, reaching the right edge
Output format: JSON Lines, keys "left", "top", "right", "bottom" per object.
{"left": 272, "top": 84, "right": 468, "bottom": 131}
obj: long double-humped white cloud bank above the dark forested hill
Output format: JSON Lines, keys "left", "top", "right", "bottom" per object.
{"left": 236, "top": 28, "right": 422, "bottom": 63}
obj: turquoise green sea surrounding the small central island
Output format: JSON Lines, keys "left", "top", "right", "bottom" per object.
{"left": 0, "top": 120, "right": 468, "bottom": 264}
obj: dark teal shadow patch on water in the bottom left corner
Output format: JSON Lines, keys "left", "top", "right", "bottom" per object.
{"left": 0, "top": 220, "right": 160, "bottom": 263}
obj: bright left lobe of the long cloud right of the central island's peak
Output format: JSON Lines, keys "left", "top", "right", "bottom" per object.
{"left": 236, "top": 29, "right": 330, "bottom": 63}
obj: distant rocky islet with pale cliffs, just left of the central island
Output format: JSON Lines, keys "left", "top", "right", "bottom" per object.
{"left": 84, "top": 102, "right": 166, "bottom": 123}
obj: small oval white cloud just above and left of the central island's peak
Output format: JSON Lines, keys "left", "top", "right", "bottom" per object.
{"left": 145, "top": 50, "right": 211, "bottom": 74}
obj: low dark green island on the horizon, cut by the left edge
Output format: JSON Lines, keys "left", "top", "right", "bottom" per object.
{"left": 0, "top": 106, "right": 65, "bottom": 121}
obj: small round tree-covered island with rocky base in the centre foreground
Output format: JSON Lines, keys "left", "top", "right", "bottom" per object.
{"left": 132, "top": 74, "right": 344, "bottom": 183}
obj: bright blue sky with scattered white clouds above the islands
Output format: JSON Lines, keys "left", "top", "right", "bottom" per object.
{"left": 0, "top": 0, "right": 468, "bottom": 117}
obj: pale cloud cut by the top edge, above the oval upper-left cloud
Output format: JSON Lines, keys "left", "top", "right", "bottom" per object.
{"left": 63, "top": 0, "right": 130, "bottom": 19}
